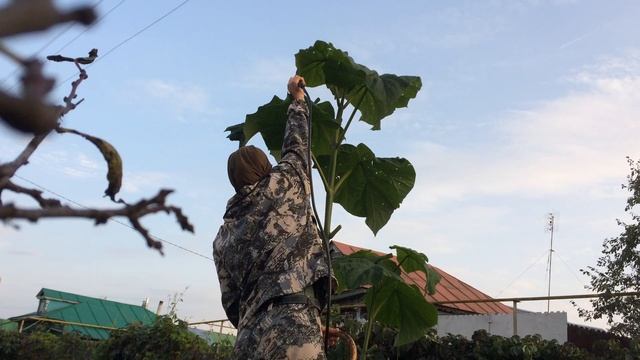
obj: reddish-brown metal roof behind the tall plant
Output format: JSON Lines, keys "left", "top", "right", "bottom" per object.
{"left": 333, "top": 241, "right": 512, "bottom": 314}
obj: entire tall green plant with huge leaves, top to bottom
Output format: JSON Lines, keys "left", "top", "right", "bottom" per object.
{"left": 226, "top": 41, "right": 438, "bottom": 349}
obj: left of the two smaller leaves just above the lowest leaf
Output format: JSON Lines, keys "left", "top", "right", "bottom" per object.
{"left": 332, "top": 250, "right": 402, "bottom": 292}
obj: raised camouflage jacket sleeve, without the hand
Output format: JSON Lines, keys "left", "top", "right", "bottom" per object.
{"left": 280, "top": 100, "right": 309, "bottom": 182}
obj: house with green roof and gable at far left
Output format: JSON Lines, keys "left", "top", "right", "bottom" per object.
{"left": 9, "top": 288, "right": 156, "bottom": 340}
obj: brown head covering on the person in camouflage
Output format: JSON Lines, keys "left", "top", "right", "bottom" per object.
{"left": 227, "top": 145, "right": 271, "bottom": 192}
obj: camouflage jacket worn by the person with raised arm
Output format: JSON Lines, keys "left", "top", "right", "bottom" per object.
{"left": 213, "top": 101, "right": 328, "bottom": 328}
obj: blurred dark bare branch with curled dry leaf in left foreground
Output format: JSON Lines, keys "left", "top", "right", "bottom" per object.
{"left": 0, "top": 0, "right": 194, "bottom": 254}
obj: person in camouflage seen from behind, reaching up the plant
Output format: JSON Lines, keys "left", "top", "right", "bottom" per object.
{"left": 213, "top": 76, "right": 328, "bottom": 359}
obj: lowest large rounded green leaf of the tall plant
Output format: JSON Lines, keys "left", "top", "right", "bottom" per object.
{"left": 364, "top": 279, "right": 438, "bottom": 346}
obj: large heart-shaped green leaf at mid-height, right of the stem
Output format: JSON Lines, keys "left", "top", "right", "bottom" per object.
{"left": 319, "top": 144, "right": 416, "bottom": 234}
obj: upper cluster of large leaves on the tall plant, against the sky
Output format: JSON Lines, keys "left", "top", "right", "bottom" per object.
{"left": 226, "top": 41, "right": 422, "bottom": 238}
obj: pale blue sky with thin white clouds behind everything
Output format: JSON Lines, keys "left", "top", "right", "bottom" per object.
{"left": 0, "top": 0, "right": 640, "bottom": 327}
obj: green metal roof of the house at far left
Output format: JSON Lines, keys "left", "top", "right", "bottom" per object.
{"left": 14, "top": 288, "right": 156, "bottom": 339}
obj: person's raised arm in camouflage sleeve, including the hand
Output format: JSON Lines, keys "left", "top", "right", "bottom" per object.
{"left": 282, "top": 75, "right": 309, "bottom": 178}
